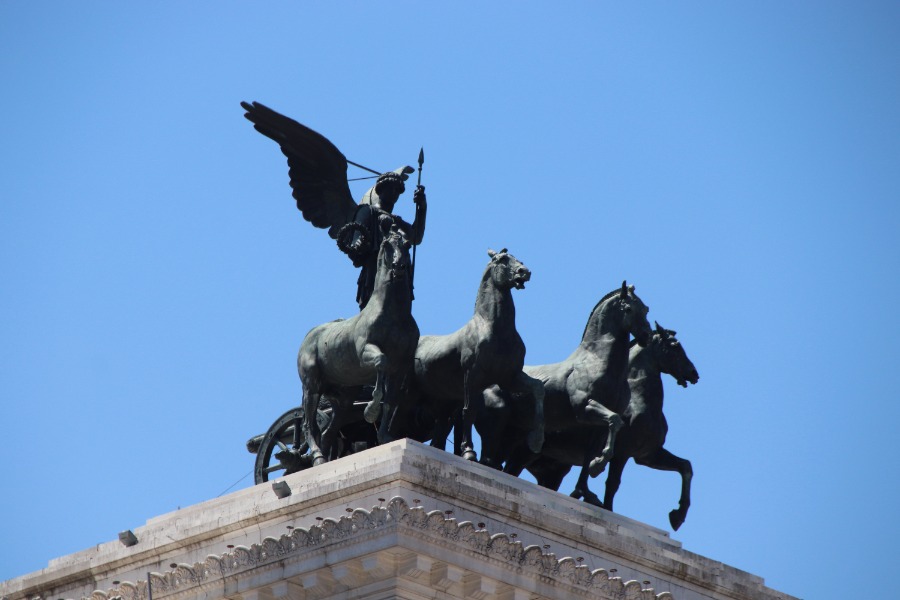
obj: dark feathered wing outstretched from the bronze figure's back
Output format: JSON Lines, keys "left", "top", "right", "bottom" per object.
{"left": 241, "top": 102, "right": 357, "bottom": 238}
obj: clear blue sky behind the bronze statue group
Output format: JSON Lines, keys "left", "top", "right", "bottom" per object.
{"left": 0, "top": 1, "right": 900, "bottom": 598}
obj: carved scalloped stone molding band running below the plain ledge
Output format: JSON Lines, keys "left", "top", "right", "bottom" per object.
{"left": 89, "top": 496, "right": 673, "bottom": 600}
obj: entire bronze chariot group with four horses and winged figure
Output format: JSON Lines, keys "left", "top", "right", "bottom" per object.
{"left": 241, "top": 102, "right": 698, "bottom": 529}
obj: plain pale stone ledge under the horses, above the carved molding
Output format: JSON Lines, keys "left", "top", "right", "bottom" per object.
{"left": 0, "top": 440, "right": 800, "bottom": 600}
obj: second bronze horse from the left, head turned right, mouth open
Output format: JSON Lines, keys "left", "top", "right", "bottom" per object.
{"left": 414, "top": 248, "right": 544, "bottom": 460}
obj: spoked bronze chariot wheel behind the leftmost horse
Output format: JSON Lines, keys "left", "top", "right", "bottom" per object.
{"left": 253, "top": 407, "right": 331, "bottom": 483}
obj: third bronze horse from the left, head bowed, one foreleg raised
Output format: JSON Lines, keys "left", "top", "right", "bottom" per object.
{"left": 479, "top": 281, "right": 652, "bottom": 505}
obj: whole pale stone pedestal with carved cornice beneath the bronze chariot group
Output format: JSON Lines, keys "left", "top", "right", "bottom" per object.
{"left": 0, "top": 440, "right": 790, "bottom": 600}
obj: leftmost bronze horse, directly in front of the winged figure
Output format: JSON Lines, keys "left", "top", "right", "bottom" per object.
{"left": 297, "top": 221, "right": 419, "bottom": 466}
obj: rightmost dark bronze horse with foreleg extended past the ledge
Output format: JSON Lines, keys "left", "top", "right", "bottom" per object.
{"left": 516, "top": 323, "right": 700, "bottom": 531}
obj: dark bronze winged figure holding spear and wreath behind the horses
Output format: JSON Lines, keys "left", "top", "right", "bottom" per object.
{"left": 241, "top": 102, "right": 427, "bottom": 310}
